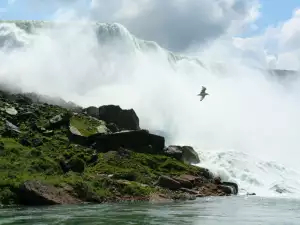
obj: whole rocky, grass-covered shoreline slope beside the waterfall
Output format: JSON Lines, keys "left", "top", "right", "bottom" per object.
{"left": 0, "top": 91, "right": 238, "bottom": 206}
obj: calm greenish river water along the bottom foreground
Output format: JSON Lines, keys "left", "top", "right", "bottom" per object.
{"left": 0, "top": 196, "right": 300, "bottom": 225}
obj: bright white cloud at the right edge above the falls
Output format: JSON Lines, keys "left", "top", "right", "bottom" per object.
{"left": 233, "top": 9, "right": 300, "bottom": 70}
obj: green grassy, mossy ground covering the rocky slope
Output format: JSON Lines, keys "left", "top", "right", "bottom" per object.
{"left": 0, "top": 92, "right": 201, "bottom": 204}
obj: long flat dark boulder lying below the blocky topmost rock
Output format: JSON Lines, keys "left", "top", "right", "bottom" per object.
{"left": 88, "top": 130, "right": 165, "bottom": 154}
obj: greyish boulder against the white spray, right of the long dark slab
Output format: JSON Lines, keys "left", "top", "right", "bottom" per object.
{"left": 164, "top": 145, "right": 200, "bottom": 164}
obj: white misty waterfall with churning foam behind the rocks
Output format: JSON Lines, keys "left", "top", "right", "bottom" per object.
{"left": 0, "top": 20, "right": 300, "bottom": 197}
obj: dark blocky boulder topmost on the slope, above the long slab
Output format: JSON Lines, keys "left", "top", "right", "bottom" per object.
{"left": 98, "top": 105, "right": 140, "bottom": 130}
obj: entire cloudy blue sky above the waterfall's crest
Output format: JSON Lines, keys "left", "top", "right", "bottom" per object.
{"left": 0, "top": 0, "right": 300, "bottom": 69}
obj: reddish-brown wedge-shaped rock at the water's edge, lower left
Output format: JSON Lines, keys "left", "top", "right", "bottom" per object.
{"left": 18, "top": 181, "right": 81, "bottom": 206}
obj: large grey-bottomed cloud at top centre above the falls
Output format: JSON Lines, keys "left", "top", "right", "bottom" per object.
{"left": 90, "top": 0, "right": 259, "bottom": 51}
